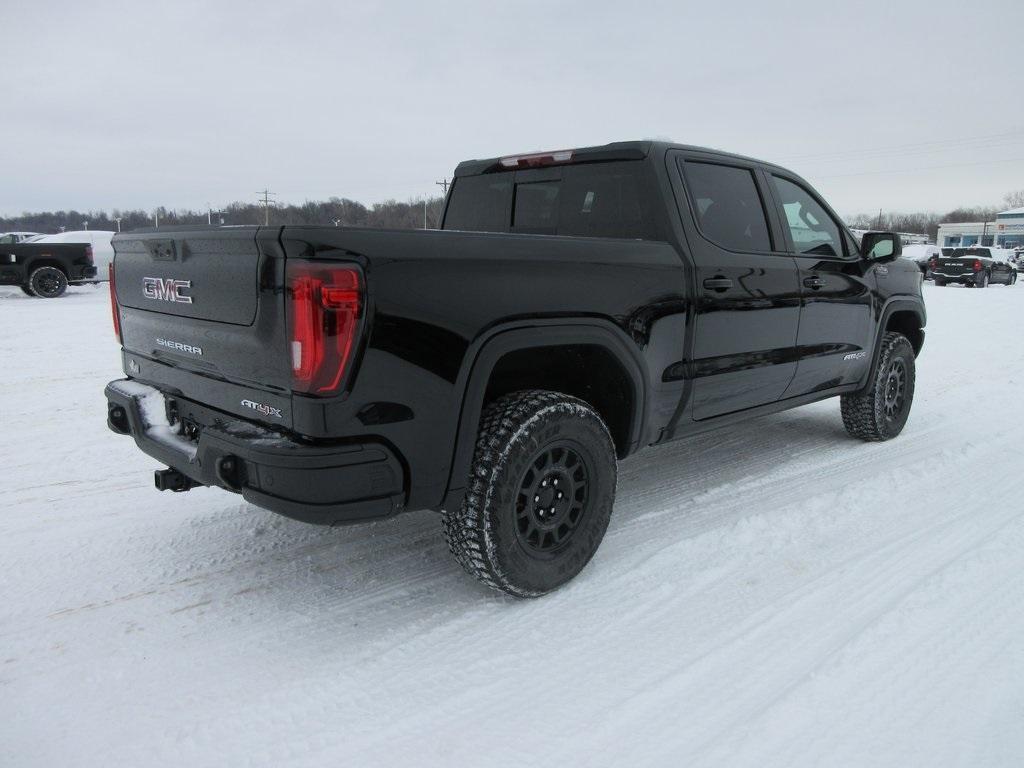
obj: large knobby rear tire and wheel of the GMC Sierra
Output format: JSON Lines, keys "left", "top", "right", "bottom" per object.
{"left": 442, "top": 390, "right": 616, "bottom": 597}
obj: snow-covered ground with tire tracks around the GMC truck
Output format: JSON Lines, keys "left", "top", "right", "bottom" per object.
{"left": 0, "top": 285, "right": 1024, "bottom": 768}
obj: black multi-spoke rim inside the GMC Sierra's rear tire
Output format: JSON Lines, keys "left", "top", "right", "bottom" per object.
{"left": 515, "top": 443, "right": 590, "bottom": 555}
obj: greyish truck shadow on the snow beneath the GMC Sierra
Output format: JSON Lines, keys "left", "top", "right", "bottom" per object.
{"left": 161, "top": 401, "right": 864, "bottom": 621}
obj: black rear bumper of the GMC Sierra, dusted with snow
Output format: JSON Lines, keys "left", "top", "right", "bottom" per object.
{"left": 105, "top": 379, "right": 404, "bottom": 525}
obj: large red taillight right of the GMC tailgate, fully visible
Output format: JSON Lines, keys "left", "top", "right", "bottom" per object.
{"left": 287, "top": 260, "right": 362, "bottom": 394}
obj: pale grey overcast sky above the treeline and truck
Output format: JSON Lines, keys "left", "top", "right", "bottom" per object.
{"left": 0, "top": 0, "right": 1024, "bottom": 215}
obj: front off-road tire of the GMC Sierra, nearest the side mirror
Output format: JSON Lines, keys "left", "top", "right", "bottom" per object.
{"left": 840, "top": 332, "right": 915, "bottom": 441}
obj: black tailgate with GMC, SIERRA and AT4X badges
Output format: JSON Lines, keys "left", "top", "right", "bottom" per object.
{"left": 114, "top": 227, "right": 291, "bottom": 427}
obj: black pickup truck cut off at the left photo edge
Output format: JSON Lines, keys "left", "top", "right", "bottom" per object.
{"left": 0, "top": 243, "right": 96, "bottom": 299}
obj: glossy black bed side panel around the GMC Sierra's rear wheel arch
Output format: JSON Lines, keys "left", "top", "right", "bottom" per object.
{"left": 282, "top": 227, "right": 688, "bottom": 508}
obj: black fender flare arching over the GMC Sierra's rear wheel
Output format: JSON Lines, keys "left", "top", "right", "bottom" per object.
{"left": 442, "top": 317, "right": 648, "bottom": 509}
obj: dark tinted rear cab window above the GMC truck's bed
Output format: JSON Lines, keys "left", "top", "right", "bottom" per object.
{"left": 441, "top": 161, "right": 665, "bottom": 241}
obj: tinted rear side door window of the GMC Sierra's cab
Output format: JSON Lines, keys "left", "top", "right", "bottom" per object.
{"left": 682, "top": 161, "right": 771, "bottom": 253}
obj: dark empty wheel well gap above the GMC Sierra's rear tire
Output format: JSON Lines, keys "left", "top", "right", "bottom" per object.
{"left": 484, "top": 344, "right": 636, "bottom": 458}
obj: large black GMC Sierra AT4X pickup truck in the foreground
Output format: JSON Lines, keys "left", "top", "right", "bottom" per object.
{"left": 106, "top": 141, "right": 926, "bottom": 597}
